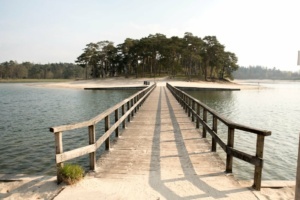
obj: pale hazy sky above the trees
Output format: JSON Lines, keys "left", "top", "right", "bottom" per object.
{"left": 0, "top": 0, "right": 300, "bottom": 71}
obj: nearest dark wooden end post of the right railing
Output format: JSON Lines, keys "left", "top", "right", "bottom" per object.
{"left": 253, "top": 135, "right": 265, "bottom": 190}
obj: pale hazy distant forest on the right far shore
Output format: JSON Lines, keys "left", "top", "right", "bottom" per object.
{"left": 233, "top": 66, "right": 300, "bottom": 80}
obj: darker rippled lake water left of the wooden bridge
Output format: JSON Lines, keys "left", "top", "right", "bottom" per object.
{"left": 0, "top": 84, "right": 137, "bottom": 174}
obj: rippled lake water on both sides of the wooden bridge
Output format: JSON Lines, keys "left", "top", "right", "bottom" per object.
{"left": 0, "top": 81, "right": 300, "bottom": 180}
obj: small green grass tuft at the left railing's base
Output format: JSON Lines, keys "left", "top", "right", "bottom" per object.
{"left": 59, "top": 164, "right": 84, "bottom": 185}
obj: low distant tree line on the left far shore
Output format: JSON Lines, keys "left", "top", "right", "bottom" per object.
{"left": 0, "top": 60, "right": 85, "bottom": 79}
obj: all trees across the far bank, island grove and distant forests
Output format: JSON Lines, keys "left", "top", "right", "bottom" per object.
{"left": 5, "top": 32, "right": 300, "bottom": 81}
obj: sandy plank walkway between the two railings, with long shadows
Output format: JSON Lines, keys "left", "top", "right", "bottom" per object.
{"left": 55, "top": 86, "right": 258, "bottom": 200}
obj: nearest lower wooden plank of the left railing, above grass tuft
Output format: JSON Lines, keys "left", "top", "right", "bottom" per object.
{"left": 56, "top": 144, "right": 96, "bottom": 162}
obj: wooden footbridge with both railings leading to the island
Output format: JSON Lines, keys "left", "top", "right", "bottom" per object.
{"left": 50, "top": 83, "right": 271, "bottom": 199}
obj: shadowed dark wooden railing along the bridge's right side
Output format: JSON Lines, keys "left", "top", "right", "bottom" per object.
{"left": 167, "top": 83, "right": 271, "bottom": 190}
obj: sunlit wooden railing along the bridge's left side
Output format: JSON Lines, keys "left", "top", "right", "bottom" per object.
{"left": 50, "top": 84, "right": 156, "bottom": 183}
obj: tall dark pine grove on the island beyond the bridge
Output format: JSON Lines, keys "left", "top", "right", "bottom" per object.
{"left": 75, "top": 33, "right": 238, "bottom": 80}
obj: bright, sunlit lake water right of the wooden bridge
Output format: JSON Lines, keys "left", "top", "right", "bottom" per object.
{"left": 188, "top": 81, "right": 300, "bottom": 180}
